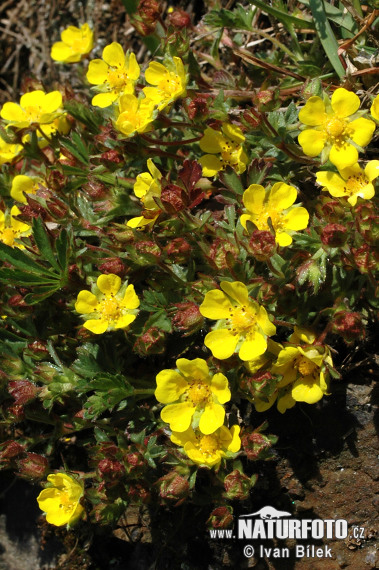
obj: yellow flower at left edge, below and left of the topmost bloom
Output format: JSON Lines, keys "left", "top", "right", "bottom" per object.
{"left": 0, "top": 90, "right": 62, "bottom": 129}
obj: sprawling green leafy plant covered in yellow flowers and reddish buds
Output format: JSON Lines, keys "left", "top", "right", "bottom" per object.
{"left": 0, "top": 0, "right": 379, "bottom": 568}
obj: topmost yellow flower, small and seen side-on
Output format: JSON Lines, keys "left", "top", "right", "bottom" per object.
{"left": 50, "top": 24, "right": 93, "bottom": 63}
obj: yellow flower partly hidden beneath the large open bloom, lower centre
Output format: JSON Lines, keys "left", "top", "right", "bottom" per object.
{"left": 171, "top": 425, "right": 241, "bottom": 467}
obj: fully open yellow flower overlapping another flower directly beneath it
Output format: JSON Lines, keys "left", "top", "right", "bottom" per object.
{"left": 155, "top": 358, "right": 230, "bottom": 434}
